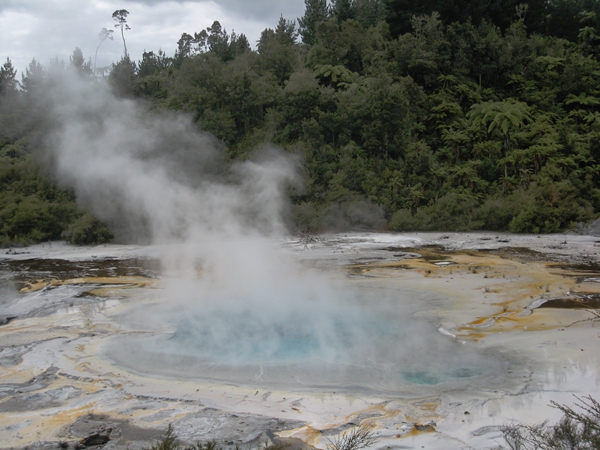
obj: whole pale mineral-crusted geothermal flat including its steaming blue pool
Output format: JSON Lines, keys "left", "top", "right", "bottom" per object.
{"left": 0, "top": 233, "right": 600, "bottom": 449}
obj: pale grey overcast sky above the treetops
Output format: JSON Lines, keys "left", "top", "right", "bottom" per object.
{"left": 0, "top": 0, "right": 304, "bottom": 76}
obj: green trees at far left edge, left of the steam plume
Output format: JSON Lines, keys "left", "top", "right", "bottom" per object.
{"left": 0, "top": 55, "right": 104, "bottom": 246}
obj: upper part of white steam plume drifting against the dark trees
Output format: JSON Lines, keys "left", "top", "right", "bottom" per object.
{"left": 44, "top": 74, "right": 300, "bottom": 243}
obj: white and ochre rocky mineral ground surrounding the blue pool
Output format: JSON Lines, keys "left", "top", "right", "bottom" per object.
{"left": 0, "top": 230, "right": 600, "bottom": 449}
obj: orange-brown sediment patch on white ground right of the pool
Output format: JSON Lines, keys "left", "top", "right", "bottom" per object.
{"left": 348, "top": 246, "right": 600, "bottom": 340}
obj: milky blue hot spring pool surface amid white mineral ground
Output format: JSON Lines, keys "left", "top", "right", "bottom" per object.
{"left": 105, "top": 281, "right": 506, "bottom": 394}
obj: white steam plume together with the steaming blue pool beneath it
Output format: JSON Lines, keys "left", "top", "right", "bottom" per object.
{"left": 37, "top": 72, "right": 496, "bottom": 389}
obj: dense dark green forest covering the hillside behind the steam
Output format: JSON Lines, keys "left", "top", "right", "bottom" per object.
{"left": 0, "top": 0, "right": 600, "bottom": 245}
